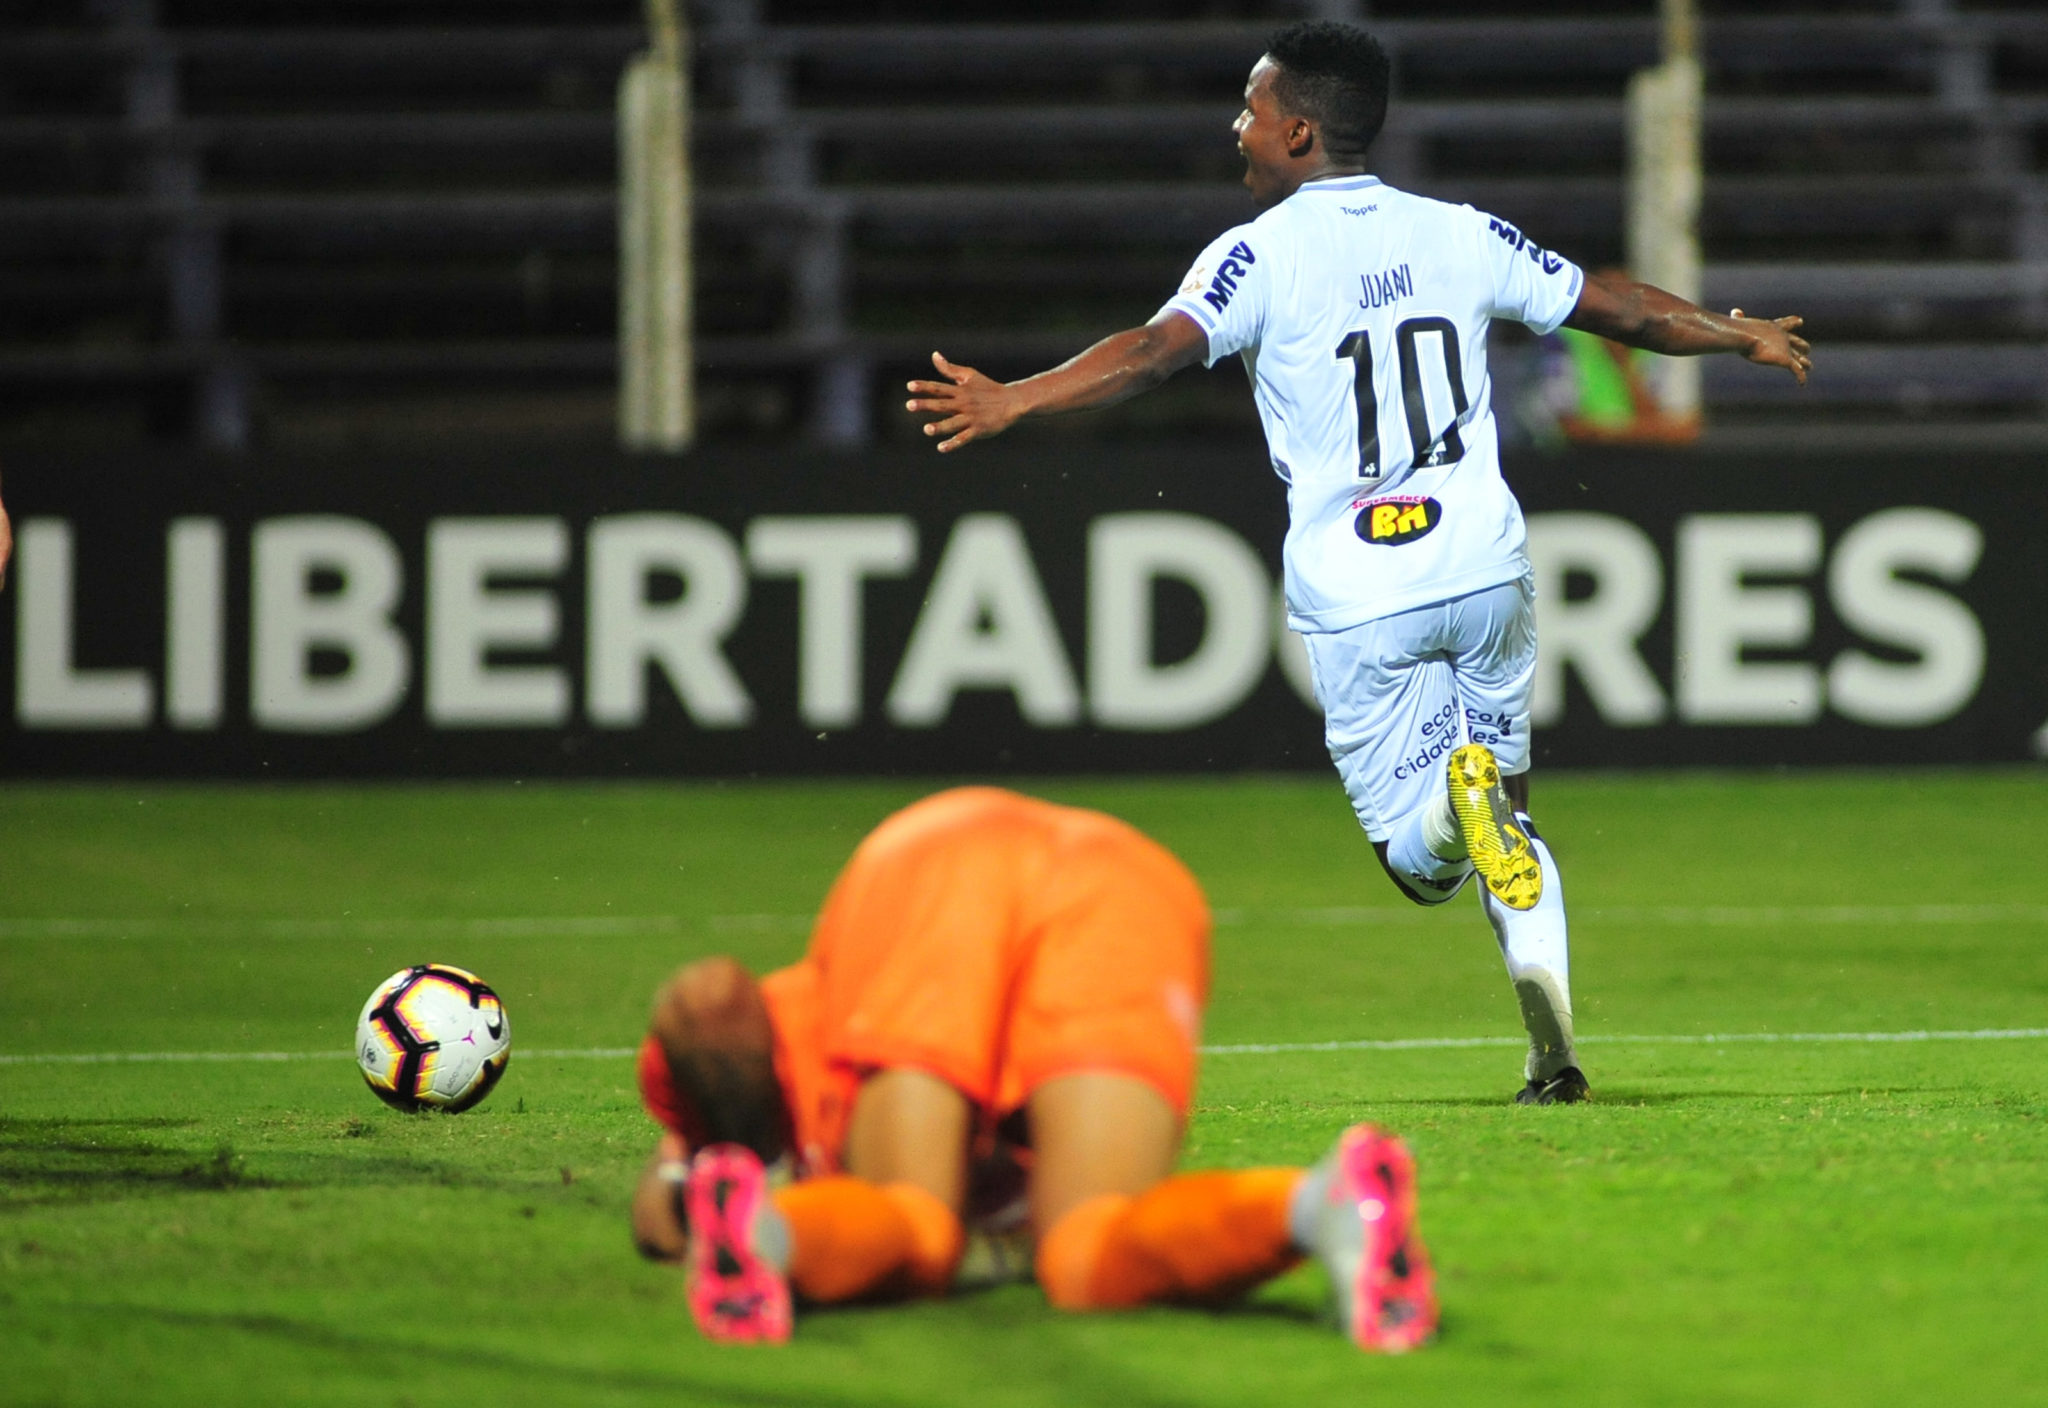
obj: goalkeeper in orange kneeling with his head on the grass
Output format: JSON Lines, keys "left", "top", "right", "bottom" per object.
{"left": 633, "top": 788, "right": 1436, "bottom": 1351}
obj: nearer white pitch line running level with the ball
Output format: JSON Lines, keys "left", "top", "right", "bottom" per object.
{"left": 0, "top": 1027, "right": 2048, "bottom": 1066}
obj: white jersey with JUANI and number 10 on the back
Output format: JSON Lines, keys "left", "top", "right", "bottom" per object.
{"left": 1163, "top": 176, "right": 1585, "bottom": 632}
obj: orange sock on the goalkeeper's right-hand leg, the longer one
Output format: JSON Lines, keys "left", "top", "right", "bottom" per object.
{"left": 1038, "top": 1169, "right": 1300, "bottom": 1310}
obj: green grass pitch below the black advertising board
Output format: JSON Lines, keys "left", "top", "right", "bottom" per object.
{"left": 0, "top": 769, "right": 2048, "bottom": 1408}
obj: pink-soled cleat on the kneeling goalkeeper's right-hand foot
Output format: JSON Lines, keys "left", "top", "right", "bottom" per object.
{"left": 1315, "top": 1124, "right": 1436, "bottom": 1355}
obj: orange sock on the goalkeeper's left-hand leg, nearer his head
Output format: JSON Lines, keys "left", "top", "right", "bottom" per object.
{"left": 774, "top": 1177, "right": 967, "bottom": 1302}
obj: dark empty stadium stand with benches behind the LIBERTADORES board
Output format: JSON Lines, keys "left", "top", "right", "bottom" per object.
{"left": 0, "top": 0, "right": 2048, "bottom": 448}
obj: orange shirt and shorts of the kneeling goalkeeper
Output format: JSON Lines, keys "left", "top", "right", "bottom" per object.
{"left": 641, "top": 788, "right": 1208, "bottom": 1173}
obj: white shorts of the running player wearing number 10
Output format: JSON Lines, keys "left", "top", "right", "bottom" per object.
{"left": 1303, "top": 581, "right": 1536, "bottom": 841}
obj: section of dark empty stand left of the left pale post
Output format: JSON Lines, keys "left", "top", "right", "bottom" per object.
{"left": 0, "top": 0, "right": 641, "bottom": 448}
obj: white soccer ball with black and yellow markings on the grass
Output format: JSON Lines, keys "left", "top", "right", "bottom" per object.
{"left": 356, "top": 964, "right": 512, "bottom": 1113}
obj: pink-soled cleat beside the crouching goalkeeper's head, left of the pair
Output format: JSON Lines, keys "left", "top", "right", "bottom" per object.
{"left": 684, "top": 1144, "right": 791, "bottom": 1345}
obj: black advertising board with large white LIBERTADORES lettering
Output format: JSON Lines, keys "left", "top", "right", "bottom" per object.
{"left": 0, "top": 436, "right": 2048, "bottom": 778}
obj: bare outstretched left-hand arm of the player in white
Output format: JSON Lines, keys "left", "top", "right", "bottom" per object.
{"left": 903, "top": 313, "right": 1208, "bottom": 452}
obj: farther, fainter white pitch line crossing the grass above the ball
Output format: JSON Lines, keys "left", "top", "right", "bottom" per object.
{"left": 0, "top": 905, "right": 2048, "bottom": 941}
